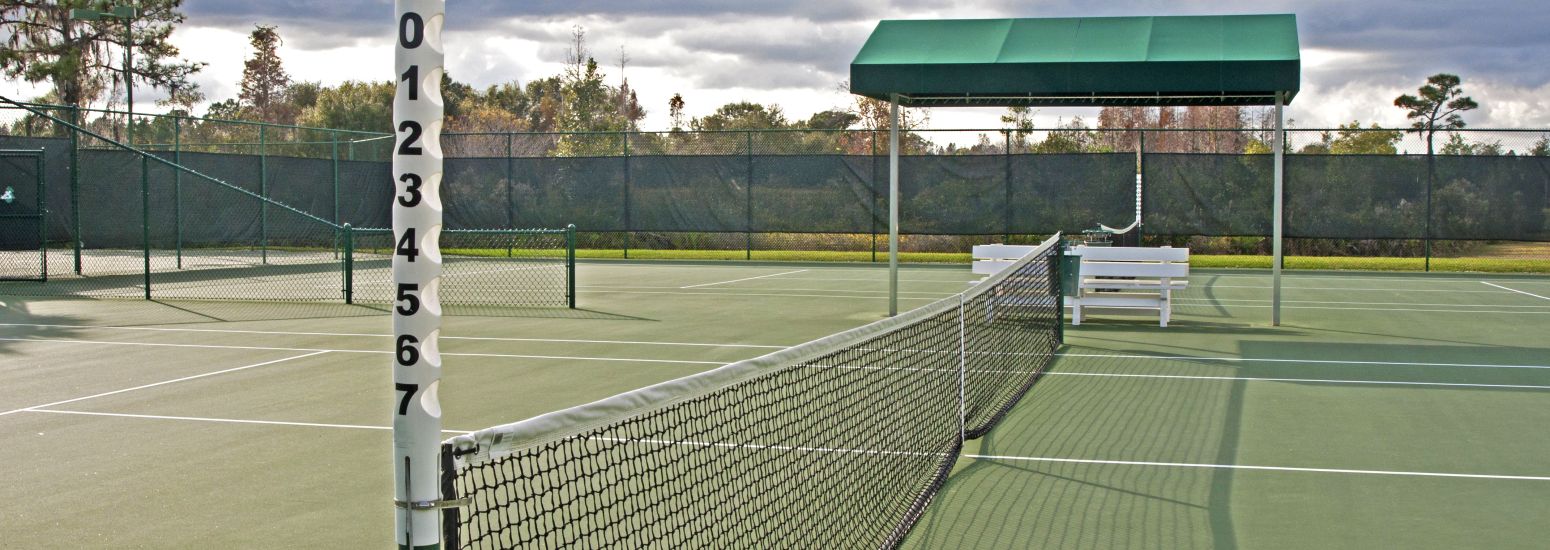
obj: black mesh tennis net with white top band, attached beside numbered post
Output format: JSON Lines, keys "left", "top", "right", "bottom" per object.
{"left": 442, "top": 235, "right": 1062, "bottom": 548}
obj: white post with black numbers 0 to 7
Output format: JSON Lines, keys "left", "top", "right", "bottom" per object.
{"left": 392, "top": 0, "right": 450, "bottom": 548}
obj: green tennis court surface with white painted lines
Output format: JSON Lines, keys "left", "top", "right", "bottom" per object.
{"left": 0, "top": 262, "right": 1550, "bottom": 548}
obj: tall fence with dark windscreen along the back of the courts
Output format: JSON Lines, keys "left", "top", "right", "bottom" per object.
{"left": 0, "top": 101, "right": 1550, "bottom": 275}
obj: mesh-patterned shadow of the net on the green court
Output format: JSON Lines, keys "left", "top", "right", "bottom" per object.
{"left": 904, "top": 347, "right": 1246, "bottom": 548}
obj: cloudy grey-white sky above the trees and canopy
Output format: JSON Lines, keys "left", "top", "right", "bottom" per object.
{"left": 8, "top": 0, "right": 1550, "bottom": 130}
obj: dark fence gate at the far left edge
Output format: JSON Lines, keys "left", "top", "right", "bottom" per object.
{"left": 0, "top": 149, "right": 48, "bottom": 280}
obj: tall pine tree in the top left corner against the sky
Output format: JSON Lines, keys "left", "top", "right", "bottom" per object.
{"left": 0, "top": 0, "right": 205, "bottom": 105}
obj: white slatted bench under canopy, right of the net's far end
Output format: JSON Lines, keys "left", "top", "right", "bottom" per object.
{"left": 1068, "top": 246, "right": 1189, "bottom": 327}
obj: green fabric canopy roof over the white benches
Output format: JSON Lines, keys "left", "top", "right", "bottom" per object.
{"left": 851, "top": 14, "right": 1300, "bottom": 107}
